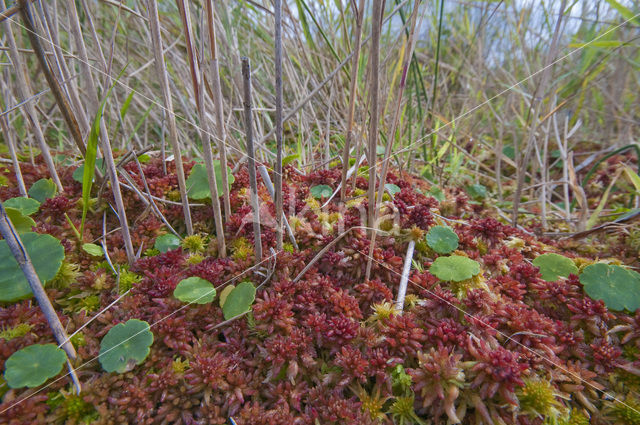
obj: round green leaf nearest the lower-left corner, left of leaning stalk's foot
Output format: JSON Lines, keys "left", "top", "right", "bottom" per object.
{"left": 4, "top": 344, "right": 67, "bottom": 388}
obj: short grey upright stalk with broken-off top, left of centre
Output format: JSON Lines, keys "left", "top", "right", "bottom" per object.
{"left": 242, "top": 58, "right": 262, "bottom": 264}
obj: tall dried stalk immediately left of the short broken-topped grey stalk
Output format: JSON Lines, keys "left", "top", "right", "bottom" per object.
{"left": 205, "top": 0, "right": 231, "bottom": 220}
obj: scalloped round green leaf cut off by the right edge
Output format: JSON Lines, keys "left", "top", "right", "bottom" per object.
{"left": 580, "top": 263, "right": 640, "bottom": 311}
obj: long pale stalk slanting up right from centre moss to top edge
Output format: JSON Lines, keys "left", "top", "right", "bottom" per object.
{"left": 365, "top": 0, "right": 420, "bottom": 280}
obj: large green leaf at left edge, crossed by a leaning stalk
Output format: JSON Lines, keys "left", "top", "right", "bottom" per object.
{"left": 0, "top": 232, "right": 64, "bottom": 302}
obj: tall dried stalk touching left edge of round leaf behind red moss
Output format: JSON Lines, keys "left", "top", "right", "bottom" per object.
{"left": 147, "top": 0, "right": 193, "bottom": 235}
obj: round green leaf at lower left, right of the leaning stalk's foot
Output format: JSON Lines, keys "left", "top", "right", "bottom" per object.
{"left": 99, "top": 319, "right": 153, "bottom": 373}
